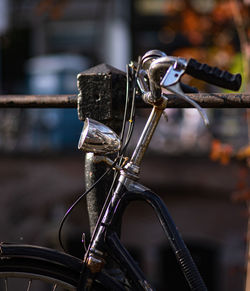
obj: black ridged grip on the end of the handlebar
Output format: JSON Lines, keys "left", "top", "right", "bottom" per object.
{"left": 186, "top": 59, "right": 242, "bottom": 91}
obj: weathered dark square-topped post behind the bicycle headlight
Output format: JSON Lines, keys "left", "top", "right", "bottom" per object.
{"left": 77, "top": 64, "right": 126, "bottom": 233}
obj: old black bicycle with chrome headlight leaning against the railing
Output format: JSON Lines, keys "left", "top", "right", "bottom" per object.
{"left": 0, "top": 50, "right": 241, "bottom": 291}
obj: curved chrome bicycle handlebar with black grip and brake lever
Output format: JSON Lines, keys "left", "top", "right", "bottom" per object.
{"left": 137, "top": 50, "right": 242, "bottom": 125}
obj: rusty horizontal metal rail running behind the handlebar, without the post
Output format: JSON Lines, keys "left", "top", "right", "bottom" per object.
{"left": 0, "top": 93, "right": 250, "bottom": 108}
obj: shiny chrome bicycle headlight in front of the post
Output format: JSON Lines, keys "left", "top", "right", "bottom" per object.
{"left": 78, "top": 118, "right": 121, "bottom": 155}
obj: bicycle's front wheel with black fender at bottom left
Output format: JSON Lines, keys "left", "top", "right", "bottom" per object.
{"left": 0, "top": 244, "right": 125, "bottom": 291}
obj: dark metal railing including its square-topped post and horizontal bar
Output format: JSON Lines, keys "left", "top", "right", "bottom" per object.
{"left": 0, "top": 64, "right": 250, "bottom": 238}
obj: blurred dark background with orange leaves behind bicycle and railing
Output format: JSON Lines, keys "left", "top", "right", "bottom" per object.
{"left": 0, "top": 0, "right": 250, "bottom": 291}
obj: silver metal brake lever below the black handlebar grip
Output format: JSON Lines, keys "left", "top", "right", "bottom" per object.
{"left": 160, "top": 58, "right": 209, "bottom": 127}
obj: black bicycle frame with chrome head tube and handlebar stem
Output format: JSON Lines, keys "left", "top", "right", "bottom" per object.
{"left": 81, "top": 97, "right": 207, "bottom": 290}
